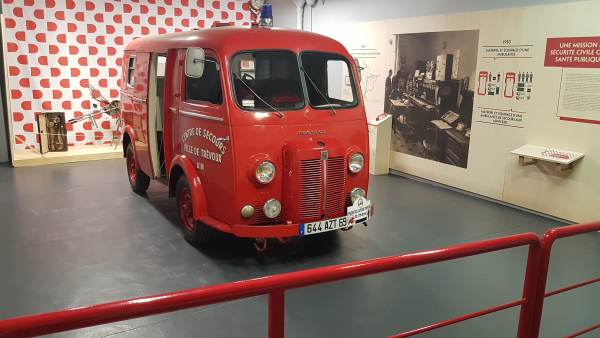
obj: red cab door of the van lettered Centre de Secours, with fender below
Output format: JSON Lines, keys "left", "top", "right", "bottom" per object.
{"left": 178, "top": 49, "right": 235, "bottom": 224}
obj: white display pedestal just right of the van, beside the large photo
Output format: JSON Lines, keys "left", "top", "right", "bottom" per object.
{"left": 369, "top": 115, "right": 392, "bottom": 175}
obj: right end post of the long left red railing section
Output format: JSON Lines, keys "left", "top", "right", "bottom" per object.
{"left": 517, "top": 241, "right": 541, "bottom": 338}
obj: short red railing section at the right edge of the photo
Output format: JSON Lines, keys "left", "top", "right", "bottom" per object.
{"left": 530, "top": 221, "right": 600, "bottom": 338}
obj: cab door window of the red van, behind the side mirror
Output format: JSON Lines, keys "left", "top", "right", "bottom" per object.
{"left": 185, "top": 57, "right": 223, "bottom": 104}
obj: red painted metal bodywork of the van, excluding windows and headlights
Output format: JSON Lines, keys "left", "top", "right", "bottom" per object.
{"left": 121, "top": 27, "right": 369, "bottom": 237}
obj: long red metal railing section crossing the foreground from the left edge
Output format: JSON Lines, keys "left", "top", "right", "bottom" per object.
{"left": 0, "top": 233, "right": 540, "bottom": 338}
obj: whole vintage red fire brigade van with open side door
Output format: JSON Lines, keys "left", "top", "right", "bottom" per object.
{"left": 121, "top": 25, "right": 373, "bottom": 248}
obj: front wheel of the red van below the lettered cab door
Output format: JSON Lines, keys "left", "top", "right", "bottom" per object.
{"left": 175, "top": 175, "right": 218, "bottom": 245}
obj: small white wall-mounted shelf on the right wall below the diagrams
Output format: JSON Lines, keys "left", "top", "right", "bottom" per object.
{"left": 510, "top": 144, "right": 585, "bottom": 174}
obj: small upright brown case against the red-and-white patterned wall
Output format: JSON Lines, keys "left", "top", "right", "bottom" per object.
{"left": 36, "top": 112, "right": 68, "bottom": 154}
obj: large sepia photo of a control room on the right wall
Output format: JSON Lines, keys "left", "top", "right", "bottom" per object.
{"left": 384, "top": 30, "right": 479, "bottom": 168}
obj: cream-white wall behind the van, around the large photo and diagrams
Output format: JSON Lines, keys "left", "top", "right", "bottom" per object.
{"left": 270, "top": 0, "right": 600, "bottom": 223}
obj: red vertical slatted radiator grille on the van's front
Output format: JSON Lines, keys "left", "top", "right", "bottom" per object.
{"left": 299, "top": 156, "right": 346, "bottom": 219}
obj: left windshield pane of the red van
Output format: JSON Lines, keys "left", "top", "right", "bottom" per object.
{"left": 230, "top": 51, "right": 305, "bottom": 111}
